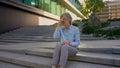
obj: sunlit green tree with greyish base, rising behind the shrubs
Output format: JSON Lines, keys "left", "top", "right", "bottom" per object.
{"left": 81, "top": 0, "right": 105, "bottom": 26}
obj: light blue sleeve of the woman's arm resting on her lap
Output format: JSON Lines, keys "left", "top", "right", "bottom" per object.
{"left": 70, "top": 29, "right": 80, "bottom": 47}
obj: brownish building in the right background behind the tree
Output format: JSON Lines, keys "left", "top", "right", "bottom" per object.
{"left": 98, "top": 0, "right": 120, "bottom": 20}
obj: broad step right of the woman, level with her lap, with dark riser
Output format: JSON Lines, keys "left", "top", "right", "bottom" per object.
{"left": 79, "top": 40, "right": 120, "bottom": 54}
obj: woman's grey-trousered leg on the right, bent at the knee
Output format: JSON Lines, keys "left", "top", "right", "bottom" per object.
{"left": 59, "top": 45, "right": 77, "bottom": 68}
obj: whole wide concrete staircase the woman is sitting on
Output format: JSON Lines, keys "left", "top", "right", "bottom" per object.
{"left": 0, "top": 26, "right": 120, "bottom": 68}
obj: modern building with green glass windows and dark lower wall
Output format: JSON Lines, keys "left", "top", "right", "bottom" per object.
{"left": 0, "top": 0, "right": 85, "bottom": 33}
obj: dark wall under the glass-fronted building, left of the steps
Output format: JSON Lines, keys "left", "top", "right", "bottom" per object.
{"left": 0, "top": 3, "right": 39, "bottom": 33}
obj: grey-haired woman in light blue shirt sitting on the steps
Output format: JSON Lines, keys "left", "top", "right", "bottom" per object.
{"left": 52, "top": 13, "right": 80, "bottom": 68}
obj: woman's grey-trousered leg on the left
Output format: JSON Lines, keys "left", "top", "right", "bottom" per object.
{"left": 52, "top": 44, "right": 62, "bottom": 68}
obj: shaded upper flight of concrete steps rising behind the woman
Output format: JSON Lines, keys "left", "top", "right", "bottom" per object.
{"left": 0, "top": 26, "right": 106, "bottom": 41}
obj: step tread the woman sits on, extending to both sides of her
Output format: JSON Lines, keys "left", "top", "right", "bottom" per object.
{"left": 1, "top": 47, "right": 120, "bottom": 60}
